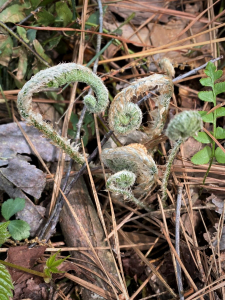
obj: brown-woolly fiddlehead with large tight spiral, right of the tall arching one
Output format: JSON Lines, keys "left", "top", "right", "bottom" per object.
{"left": 109, "top": 74, "right": 173, "bottom": 137}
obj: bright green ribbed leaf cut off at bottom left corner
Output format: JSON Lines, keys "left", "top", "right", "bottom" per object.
{"left": 0, "top": 264, "right": 14, "bottom": 300}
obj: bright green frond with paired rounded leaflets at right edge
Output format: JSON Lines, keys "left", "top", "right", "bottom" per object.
{"left": 191, "top": 62, "right": 225, "bottom": 184}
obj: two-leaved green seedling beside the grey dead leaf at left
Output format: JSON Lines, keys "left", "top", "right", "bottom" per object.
{"left": 0, "top": 198, "right": 30, "bottom": 244}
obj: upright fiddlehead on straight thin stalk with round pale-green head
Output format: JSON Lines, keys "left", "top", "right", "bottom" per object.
{"left": 162, "top": 111, "right": 203, "bottom": 206}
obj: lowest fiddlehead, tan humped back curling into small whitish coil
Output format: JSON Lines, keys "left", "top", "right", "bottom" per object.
{"left": 101, "top": 144, "right": 158, "bottom": 207}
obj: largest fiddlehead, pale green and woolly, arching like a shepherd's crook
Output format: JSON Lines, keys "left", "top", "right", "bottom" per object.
{"left": 17, "top": 63, "right": 108, "bottom": 163}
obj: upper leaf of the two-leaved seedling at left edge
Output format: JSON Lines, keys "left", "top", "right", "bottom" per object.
{"left": 2, "top": 198, "right": 25, "bottom": 220}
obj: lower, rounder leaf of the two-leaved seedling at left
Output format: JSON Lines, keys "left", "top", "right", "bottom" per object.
{"left": 8, "top": 220, "right": 30, "bottom": 241}
